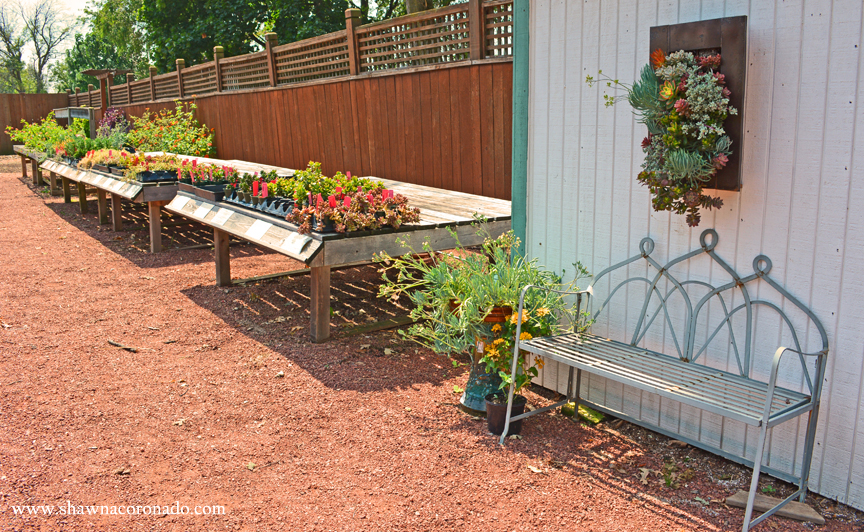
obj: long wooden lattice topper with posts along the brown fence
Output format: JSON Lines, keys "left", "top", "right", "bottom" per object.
{"left": 69, "top": 0, "right": 513, "bottom": 107}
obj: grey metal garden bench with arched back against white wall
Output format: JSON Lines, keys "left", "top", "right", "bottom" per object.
{"left": 501, "top": 229, "right": 828, "bottom": 532}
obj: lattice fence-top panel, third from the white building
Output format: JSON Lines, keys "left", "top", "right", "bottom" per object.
{"left": 273, "top": 30, "right": 350, "bottom": 85}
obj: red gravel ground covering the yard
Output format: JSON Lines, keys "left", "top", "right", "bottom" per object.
{"left": 0, "top": 157, "right": 864, "bottom": 532}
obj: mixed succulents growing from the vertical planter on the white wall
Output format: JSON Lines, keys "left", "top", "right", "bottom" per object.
{"left": 586, "top": 48, "right": 738, "bottom": 227}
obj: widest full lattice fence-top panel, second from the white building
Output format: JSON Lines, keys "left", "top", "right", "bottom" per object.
{"left": 356, "top": 4, "right": 470, "bottom": 72}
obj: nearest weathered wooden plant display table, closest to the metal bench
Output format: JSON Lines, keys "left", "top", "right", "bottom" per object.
{"left": 165, "top": 180, "right": 510, "bottom": 342}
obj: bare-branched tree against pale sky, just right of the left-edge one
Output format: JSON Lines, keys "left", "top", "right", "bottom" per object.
{"left": 19, "top": 0, "right": 73, "bottom": 92}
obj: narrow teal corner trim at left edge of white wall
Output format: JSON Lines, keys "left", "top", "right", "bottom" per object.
{"left": 510, "top": 0, "right": 529, "bottom": 255}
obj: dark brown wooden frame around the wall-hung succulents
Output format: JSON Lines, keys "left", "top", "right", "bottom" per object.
{"left": 650, "top": 15, "right": 747, "bottom": 190}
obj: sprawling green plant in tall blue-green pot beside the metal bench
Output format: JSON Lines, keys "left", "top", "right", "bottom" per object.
{"left": 376, "top": 229, "right": 587, "bottom": 422}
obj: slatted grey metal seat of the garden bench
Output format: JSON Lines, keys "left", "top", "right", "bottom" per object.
{"left": 520, "top": 334, "right": 810, "bottom": 425}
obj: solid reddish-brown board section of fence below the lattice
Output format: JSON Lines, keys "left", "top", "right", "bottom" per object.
{"left": 121, "top": 61, "right": 513, "bottom": 199}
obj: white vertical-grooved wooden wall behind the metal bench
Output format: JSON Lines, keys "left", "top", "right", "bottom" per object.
{"left": 527, "top": 0, "right": 864, "bottom": 508}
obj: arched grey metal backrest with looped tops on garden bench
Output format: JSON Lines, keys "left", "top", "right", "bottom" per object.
{"left": 589, "top": 229, "right": 828, "bottom": 391}
